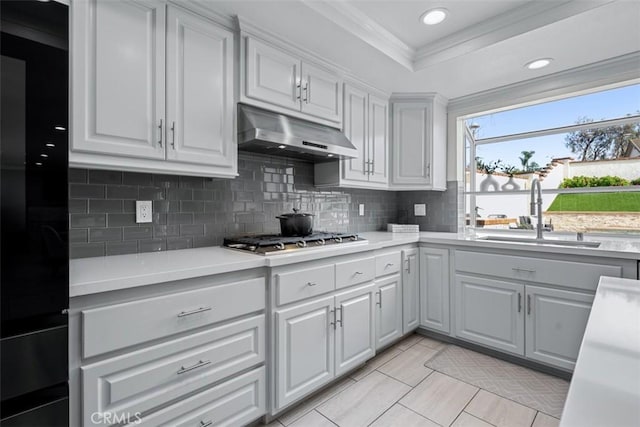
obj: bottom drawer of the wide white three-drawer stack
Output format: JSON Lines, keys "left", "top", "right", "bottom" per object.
{"left": 127, "top": 367, "right": 266, "bottom": 427}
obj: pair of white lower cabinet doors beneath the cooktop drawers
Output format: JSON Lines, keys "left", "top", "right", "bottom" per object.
{"left": 275, "top": 283, "right": 376, "bottom": 409}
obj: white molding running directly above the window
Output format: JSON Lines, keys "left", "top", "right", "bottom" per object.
{"left": 448, "top": 51, "right": 640, "bottom": 117}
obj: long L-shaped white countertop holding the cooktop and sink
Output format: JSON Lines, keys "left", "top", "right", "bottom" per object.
{"left": 69, "top": 232, "right": 640, "bottom": 297}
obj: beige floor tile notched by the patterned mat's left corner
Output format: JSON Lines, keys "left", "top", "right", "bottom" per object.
{"left": 378, "top": 346, "right": 438, "bottom": 387}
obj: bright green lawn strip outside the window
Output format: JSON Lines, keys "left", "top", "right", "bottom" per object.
{"left": 548, "top": 191, "right": 640, "bottom": 212}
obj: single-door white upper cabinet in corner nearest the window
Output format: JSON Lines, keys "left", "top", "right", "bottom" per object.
{"left": 390, "top": 94, "right": 447, "bottom": 190}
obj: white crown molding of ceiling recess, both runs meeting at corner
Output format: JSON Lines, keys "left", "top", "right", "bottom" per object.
{"left": 301, "top": 0, "right": 615, "bottom": 71}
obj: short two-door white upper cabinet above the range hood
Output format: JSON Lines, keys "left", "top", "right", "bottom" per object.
{"left": 241, "top": 35, "right": 342, "bottom": 127}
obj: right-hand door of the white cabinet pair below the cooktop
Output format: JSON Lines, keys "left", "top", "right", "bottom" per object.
{"left": 335, "top": 283, "right": 376, "bottom": 376}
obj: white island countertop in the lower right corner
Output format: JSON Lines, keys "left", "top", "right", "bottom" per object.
{"left": 560, "top": 277, "right": 640, "bottom": 427}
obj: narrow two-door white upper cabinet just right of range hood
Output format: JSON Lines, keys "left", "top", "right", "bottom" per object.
{"left": 315, "top": 83, "right": 389, "bottom": 189}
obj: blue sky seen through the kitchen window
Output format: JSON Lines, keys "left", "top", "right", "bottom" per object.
{"left": 467, "top": 84, "right": 640, "bottom": 171}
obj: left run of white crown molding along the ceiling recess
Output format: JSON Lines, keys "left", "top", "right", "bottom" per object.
{"left": 301, "top": 0, "right": 416, "bottom": 71}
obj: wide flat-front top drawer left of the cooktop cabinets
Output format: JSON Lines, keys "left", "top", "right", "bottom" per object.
{"left": 82, "top": 278, "right": 265, "bottom": 357}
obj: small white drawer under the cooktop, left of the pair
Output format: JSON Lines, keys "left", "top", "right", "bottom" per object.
{"left": 276, "top": 264, "right": 335, "bottom": 305}
